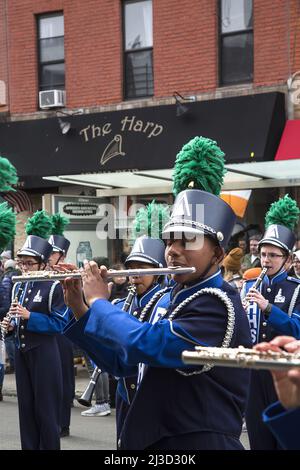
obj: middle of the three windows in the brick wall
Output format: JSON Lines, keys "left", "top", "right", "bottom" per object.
{"left": 124, "top": 0, "right": 153, "bottom": 99}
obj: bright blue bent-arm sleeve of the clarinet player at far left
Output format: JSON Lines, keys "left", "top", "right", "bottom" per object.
{"left": 27, "top": 283, "right": 70, "bottom": 335}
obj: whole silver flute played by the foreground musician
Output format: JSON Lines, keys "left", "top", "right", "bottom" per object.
{"left": 12, "top": 266, "right": 196, "bottom": 282}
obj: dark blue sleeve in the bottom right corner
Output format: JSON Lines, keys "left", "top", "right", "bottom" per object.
{"left": 263, "top": 402, "right": 300, "bottom": 450}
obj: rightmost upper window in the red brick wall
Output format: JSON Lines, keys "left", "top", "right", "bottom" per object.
{"left": 220, "top": 0, "right": 253, "bottom": 85}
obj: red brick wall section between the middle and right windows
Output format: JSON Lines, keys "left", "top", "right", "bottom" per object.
{"left": 153, "top": 0, "right": 218, "bottom": 96}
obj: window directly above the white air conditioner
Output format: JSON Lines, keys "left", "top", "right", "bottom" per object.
{"left": 38, "top": 13, "right": 65, "bottom": 91}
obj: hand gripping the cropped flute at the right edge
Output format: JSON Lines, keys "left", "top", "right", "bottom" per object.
{"left": 254, "top": 336, "right": 300, "bottom": 409}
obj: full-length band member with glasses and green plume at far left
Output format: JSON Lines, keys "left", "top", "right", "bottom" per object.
{"left": 3, "top": 211, "right": 67, "bottom": 450}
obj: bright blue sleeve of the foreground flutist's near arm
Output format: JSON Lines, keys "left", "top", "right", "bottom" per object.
{"left": 84, "top": 300, "right": 210, "bottom": 368}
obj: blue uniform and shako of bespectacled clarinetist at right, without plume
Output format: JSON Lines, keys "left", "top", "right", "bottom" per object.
{"left": 241, "top": 218, "right": 300, "bottom": 450}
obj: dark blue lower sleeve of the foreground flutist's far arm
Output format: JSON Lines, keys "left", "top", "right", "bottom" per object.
{"left": 63, "top": 310, "right": 137, "bottom": 377}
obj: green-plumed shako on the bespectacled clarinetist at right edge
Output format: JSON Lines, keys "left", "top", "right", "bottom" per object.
{"left": 259, "top": 194, "right": 300, "bottom": 253}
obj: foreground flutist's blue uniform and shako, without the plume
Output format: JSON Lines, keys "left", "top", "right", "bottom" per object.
{"left": 65, "top": 185, "right": 251, "bottom": 450}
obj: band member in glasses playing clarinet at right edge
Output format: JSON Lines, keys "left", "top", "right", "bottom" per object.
{"left": 242, "top": 195, "right": 300, "bottom": 450}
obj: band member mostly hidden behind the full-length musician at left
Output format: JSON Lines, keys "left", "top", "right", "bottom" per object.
{"left": 48, "top": 213, "right": 75, "bottom": 437}
